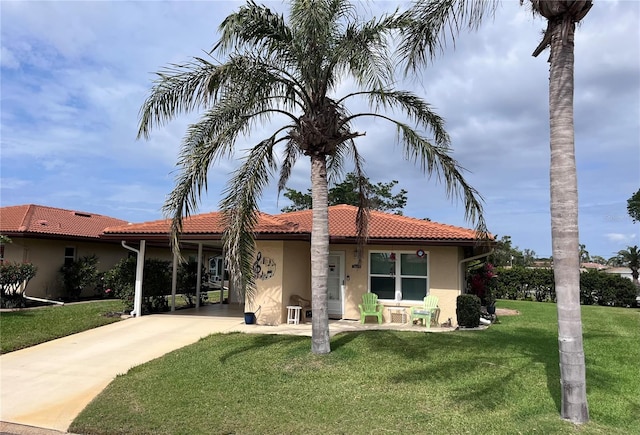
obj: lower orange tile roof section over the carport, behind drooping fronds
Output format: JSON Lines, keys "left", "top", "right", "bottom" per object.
{"left": 104, "top": 212, "right": 300, "bottom": 235}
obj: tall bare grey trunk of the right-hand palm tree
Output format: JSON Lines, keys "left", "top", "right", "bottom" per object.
{"left": 549, "top": 20, "right": 589, "bottom": 423}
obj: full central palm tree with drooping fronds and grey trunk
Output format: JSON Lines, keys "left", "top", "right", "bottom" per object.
{"left": 138, "top": 0, "right": 486, "bottom": 354}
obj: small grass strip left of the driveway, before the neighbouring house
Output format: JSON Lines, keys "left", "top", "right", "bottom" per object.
{"left": 0, "top": 300, "right": 122, "bottom": 353}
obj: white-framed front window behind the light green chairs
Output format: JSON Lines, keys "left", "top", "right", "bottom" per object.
{"left": 369, "top": 251, "right": 429, "bottom": 301}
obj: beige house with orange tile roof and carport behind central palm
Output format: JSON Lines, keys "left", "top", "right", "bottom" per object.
{"left": 102, "top": 205, "right": 490, "bottom": 324}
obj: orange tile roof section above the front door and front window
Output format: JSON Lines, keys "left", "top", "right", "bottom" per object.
{"left": 276, "top": 205, "right": 476, "bottom": 241}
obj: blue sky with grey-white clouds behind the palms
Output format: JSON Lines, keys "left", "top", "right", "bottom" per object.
{"left": 0, "top": 0, "right": 640, "bottom": 258}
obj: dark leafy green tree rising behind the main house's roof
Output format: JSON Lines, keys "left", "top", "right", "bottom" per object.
{"left": 282, "top": 172, "right": 407, "bottom": 215}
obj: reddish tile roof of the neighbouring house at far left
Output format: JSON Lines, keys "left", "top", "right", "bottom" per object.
{"left": 0, "top": 204, "right": 127, "bottom": 238}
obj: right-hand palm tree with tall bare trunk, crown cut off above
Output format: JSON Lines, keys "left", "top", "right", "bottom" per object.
{"left": 400, "top": 0, "right": 592, "bottom": 423}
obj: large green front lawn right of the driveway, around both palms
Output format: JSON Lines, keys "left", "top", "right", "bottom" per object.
{"left": 69, "top": 301, "right": 640, "bottom": 434}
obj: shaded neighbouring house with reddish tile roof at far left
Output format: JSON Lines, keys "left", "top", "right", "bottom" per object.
{"left": 0, "top": 204, "right": 128, "bottom": 299}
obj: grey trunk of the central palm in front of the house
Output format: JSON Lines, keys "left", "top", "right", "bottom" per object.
{"left": 311, "top": 155, "right": 331, "bottom": 354}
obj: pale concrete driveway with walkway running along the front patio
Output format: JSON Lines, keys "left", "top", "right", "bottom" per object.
{"left": 0, "top": 305, "right": 450, "bottom": 434}
